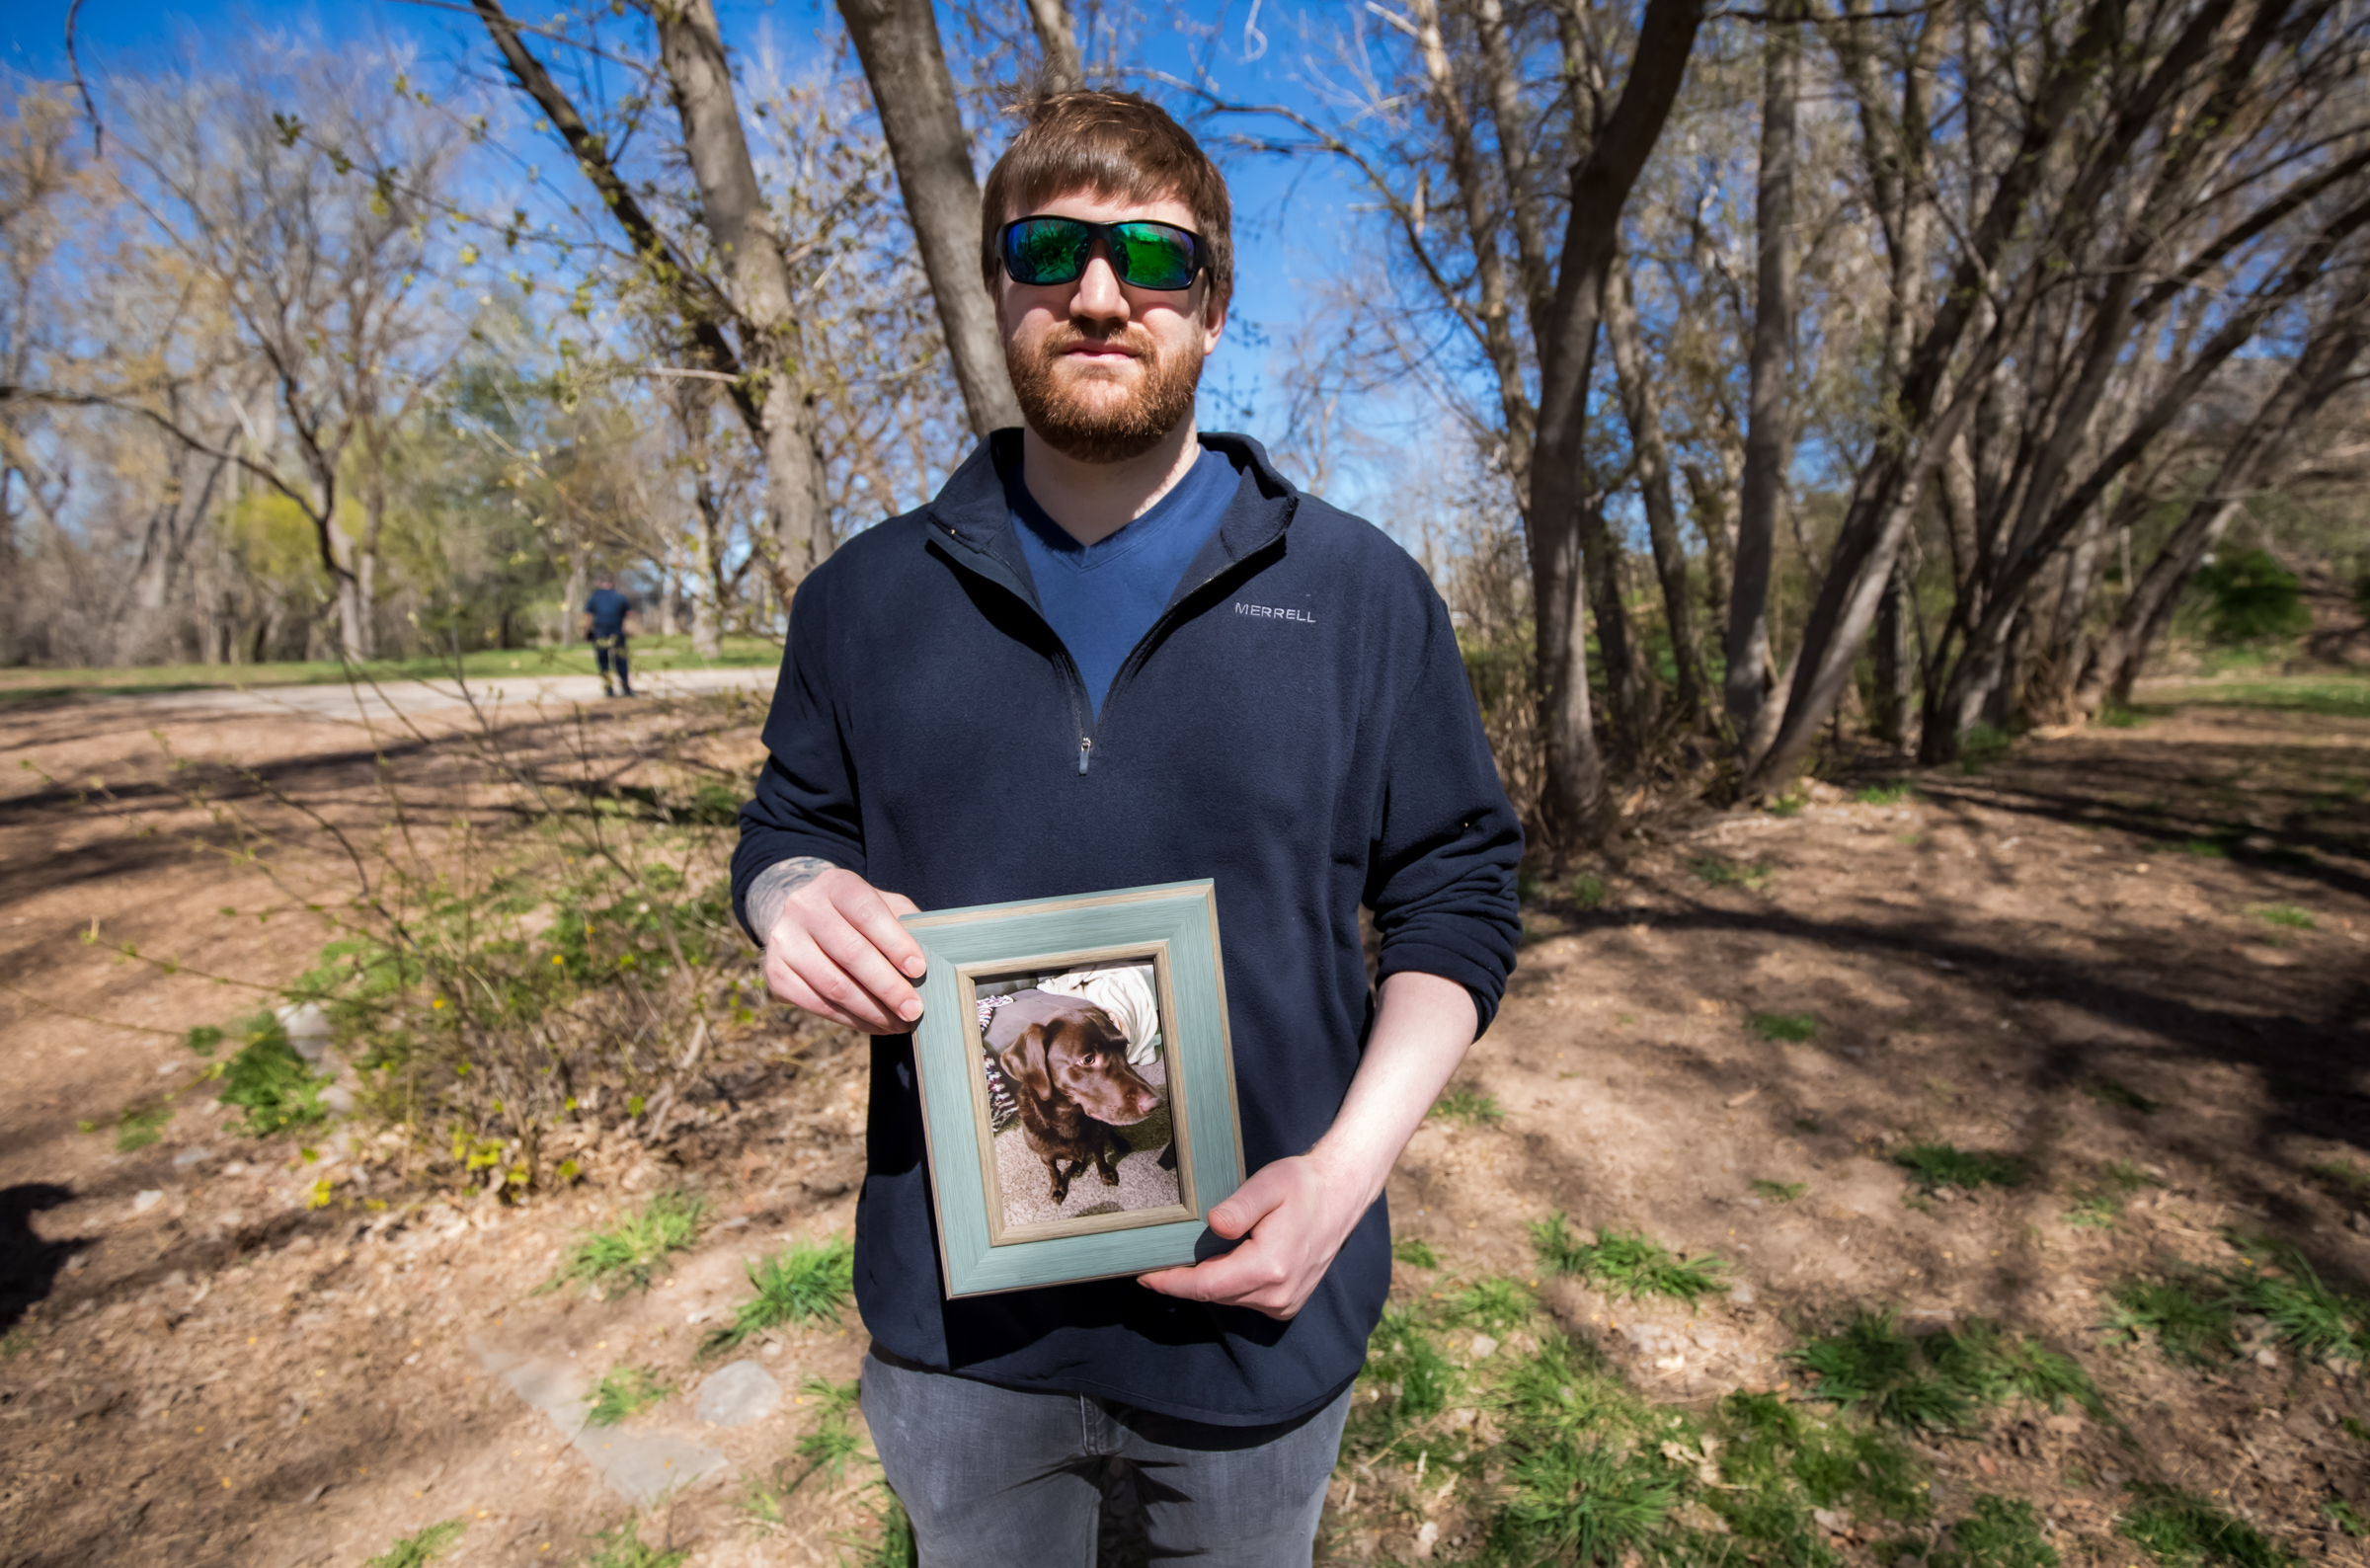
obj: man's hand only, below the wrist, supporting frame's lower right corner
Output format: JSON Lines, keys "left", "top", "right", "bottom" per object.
{"left": 1138, "top": 1153, "right": 1373, "bottom": 1319}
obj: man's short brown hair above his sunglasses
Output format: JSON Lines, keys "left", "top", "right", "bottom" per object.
{"left": 979, "top": 93, "right": 1234, "bottom": 317}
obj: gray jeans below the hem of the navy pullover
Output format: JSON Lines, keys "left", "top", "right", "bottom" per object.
{"left": 863, "top": 1353, "right": 1351, "bottom": 1568}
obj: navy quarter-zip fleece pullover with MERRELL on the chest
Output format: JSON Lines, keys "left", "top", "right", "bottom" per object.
{"left": 733, "top": 431, "right": 1522, "bottom": 1426}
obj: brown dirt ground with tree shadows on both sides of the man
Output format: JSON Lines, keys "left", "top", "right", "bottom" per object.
{"left": 0, "top": 694, "right": 2370, "bottom": 1568}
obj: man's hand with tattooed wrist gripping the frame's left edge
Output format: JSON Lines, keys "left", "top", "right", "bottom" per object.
{"left": 747, "top": 855, "right": 924, "bottom": 1035}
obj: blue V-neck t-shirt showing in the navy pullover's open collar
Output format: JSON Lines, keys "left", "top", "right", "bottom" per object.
{"left": 1005, "top": 447, "right": 1242, "bottom": 718}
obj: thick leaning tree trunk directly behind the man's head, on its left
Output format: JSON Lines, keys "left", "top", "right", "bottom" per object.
{"left": 838, "top": 0, "right": 1023, "bottom": 438}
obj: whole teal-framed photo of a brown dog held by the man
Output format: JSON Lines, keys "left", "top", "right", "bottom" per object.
{"left": 906, "top": 881, "right": 1244, "bottom": 1295}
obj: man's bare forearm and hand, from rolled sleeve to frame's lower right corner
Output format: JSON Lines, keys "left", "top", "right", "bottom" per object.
{"left": 1138, "top": 974, "right": 1474, "bottom": 1317}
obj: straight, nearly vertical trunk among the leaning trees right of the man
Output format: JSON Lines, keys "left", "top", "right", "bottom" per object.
{"left": 1723, "top": 10, "right": 1801, "bottom": 770}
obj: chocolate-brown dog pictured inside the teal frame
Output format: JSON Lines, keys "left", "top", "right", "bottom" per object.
{"left": 988, "top": 990, "right": 1161, "bottom": 1204}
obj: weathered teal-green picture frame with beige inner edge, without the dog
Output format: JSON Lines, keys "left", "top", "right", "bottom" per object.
{"left": 903, "top": 879, "right": 1244, "bottom": 1298}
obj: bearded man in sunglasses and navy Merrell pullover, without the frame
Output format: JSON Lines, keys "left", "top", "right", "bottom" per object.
{"left": 733, "top": 93, "right": 1522, "bottom": 1568}
